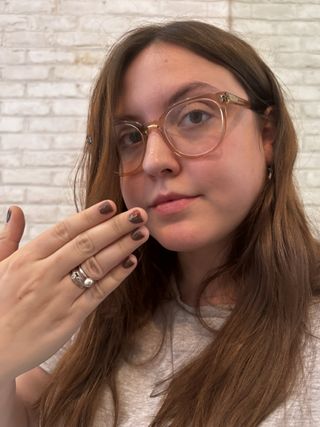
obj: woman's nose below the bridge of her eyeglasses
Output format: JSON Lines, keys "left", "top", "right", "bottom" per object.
{"left": 142, "top": 127, "right": 181, "bottom": 176}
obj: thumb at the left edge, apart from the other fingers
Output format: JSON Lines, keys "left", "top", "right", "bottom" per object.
{"left": 0, "top": 206, "right": 25, "bottom": 261}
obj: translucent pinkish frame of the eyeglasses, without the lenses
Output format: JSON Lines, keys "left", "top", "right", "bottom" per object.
{"left": 114, "top": 91, "right": 253, "bottom": 177}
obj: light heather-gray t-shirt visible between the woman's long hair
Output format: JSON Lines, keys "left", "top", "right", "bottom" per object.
{"left": 41, "top": 301, "right": 320, "bottom": 427}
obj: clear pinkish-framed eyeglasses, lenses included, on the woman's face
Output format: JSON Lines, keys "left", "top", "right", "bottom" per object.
{"left": 114, "top": 92, "right": 251, "bottom": 176}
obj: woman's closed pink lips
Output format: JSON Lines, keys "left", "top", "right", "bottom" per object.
{"left": 150, "top": 193, "right": 198, "bottom": 214}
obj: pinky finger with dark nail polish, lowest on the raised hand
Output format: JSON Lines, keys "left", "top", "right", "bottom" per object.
{"left": 75, "top": 254, "right": 137, "bottom": 314}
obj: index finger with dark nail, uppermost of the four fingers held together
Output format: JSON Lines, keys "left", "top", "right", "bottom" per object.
{"left": 25, "top": 200, "right": 117, "bottom": 259}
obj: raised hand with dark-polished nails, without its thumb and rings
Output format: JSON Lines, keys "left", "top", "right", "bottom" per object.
{"left": 0, "top": 201, "right": 149, "bottom": 380}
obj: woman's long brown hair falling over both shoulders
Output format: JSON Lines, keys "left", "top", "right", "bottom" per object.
{"left": 40, "top": 21, "right": 319, "bottom": 427}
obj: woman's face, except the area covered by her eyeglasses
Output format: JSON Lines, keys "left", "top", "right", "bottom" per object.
{"left": 117, "top": 43, "right": 272, "bottom": 252}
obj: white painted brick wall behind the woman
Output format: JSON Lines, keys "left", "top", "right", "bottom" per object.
{"left": 0, "top": 0, "right": 320, "bottom": 241}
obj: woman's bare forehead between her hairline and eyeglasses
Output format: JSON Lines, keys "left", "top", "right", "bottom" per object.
{"left": 117, "top": 42, "right": 246, "bottom": 117}
